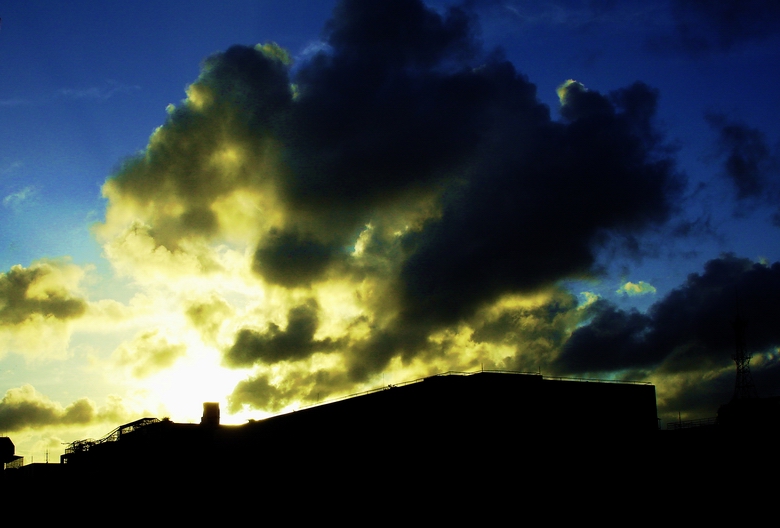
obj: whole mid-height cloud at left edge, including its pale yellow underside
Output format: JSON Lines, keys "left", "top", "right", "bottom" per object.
{"left": 0, "top": 260, "right": 88, "bottom": 358}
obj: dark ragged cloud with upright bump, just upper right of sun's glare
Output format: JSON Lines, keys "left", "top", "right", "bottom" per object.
{"left": 224, "top": 300, "right": 337, "bottom": 367}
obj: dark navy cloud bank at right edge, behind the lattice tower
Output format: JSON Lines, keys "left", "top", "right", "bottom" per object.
{"left": 557, "top": 255, "right": 780, "bottom": 386}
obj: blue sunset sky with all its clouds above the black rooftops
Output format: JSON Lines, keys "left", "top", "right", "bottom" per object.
{"left": 0, "top": 0, "right": 780, "bottom": 460}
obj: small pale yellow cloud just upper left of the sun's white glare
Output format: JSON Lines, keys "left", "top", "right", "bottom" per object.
{"left": 114, "top": 330, "right": 187, "bottom": 378}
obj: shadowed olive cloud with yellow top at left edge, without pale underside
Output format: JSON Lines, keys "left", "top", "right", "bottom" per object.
{"left": 0, "top": 261, "right": 87, "bottom": 326}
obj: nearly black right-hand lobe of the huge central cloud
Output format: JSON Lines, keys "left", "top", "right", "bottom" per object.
{"left": 402, "top": 79, "right": 682, "bottom": 323}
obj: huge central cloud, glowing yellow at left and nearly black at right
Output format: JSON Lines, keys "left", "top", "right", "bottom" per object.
{"left": 96, "top": 0, "right": 684, "bottom": 412}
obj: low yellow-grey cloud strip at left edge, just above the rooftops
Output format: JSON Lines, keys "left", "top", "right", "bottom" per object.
{"left": 0, "top": 384, "right": 130, "bottom": 431}
